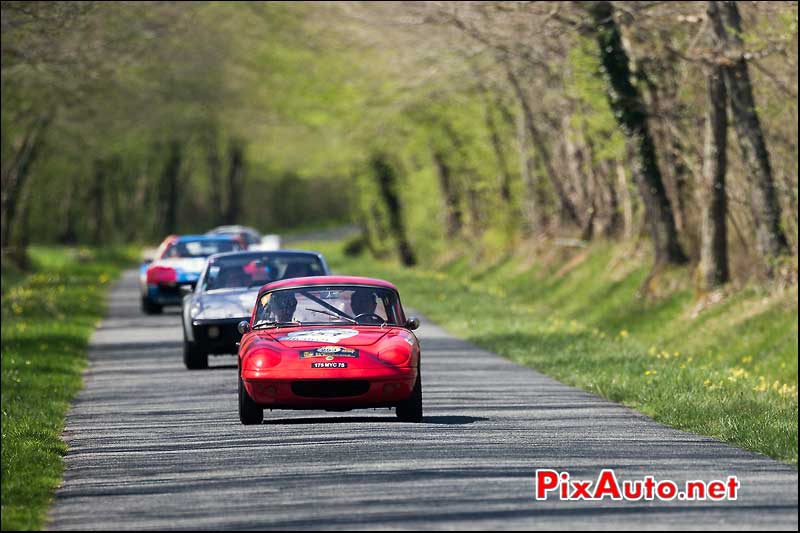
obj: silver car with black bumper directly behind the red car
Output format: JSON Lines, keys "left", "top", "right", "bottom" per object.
{"left": 182, "top": 250, "right": 330, "bottom": 369}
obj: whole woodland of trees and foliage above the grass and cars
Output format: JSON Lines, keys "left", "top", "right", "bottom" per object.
{"left": 2, "top": 1, "right": 798, "bottom": 290}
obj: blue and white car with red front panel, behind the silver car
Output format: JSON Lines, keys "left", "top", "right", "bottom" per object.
{"left": 139, "top": 235, "right": 243, "bottom": 314}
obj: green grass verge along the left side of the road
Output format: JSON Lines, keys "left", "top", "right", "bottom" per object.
{"left": 2, "top": 247, "right": 136, "bottom": 531}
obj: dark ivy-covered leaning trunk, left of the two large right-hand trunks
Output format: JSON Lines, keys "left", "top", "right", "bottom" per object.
{"left": 586, "top": 2, "right": 688, "bottom": 267}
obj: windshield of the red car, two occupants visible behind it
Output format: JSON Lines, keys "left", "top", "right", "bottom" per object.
{"left": 253, "top": 285, "right": 401, "bottom": 328}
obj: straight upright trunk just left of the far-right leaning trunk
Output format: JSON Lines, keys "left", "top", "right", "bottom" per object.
{"left": 698, "top": 56, "right": 730, "bottom": 291}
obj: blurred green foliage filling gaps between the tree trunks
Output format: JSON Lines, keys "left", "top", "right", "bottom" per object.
{"left": 0, "top": 2, "right": 797, "bottom": 270}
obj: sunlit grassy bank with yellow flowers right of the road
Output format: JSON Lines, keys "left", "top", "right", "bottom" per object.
{"left": 306, "top": 239, "right": 798, "bottom": 465}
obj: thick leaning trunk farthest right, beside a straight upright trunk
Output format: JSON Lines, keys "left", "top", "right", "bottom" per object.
{"left": 708, "top": 2, "right": 789, "bottom": 257}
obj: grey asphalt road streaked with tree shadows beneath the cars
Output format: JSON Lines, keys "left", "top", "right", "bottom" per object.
{"left": 49, "top": 272, "right": 798, "bottom": 530}
